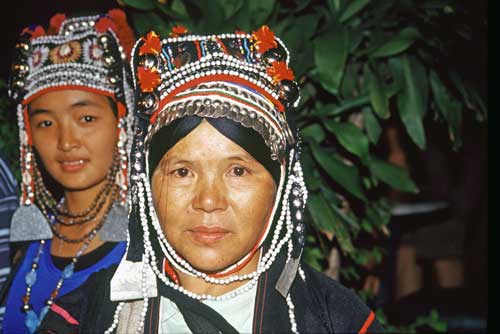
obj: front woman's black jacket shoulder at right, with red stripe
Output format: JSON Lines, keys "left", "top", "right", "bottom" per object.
{"left": 301, "top": 264, "right": 383, "bottom": 333}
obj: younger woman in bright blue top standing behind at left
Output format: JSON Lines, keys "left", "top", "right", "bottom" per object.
{"left": 2, "top": 10, "right": 134, "bottom": 333}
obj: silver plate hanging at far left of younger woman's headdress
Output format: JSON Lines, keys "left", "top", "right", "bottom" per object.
{"left": 10, "top": 205, "right": 52, "bottom": 242}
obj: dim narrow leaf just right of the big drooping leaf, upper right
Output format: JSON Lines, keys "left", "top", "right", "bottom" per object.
{"left": 429, "top": 71, "right": 462, "bottom": 146}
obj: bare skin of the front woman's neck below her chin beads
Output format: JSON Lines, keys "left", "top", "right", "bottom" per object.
{"left": 176, "top": 249, "right": 262, "bottom": 296}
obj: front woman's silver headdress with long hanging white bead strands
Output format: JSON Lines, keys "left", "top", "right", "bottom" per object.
{"left": 107, "top": 26, "right": 307, "bottom": 333}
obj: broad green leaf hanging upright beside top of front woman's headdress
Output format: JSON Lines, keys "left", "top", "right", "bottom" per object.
{"left": 313, "top": 24, "right": 349, "bottom": 95}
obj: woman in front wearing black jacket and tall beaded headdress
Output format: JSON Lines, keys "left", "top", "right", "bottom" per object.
{"left": 39, "top": 26, "right": 381, "bottom": 333}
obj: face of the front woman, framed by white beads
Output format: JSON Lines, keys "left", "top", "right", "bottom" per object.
{"left": 152, "top": 121, "right": 276, "bottom": 272}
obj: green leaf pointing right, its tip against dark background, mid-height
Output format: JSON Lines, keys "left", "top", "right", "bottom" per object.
{"left": 369, "top": 159, "right": 418, "bottom": 193}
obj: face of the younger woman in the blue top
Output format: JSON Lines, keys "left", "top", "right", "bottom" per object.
{"left": 28, "top": 90, "right": 118, "bottom": 190}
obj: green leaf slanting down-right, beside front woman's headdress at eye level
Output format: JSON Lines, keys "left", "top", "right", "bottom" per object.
{"left": 311, "top": 144, "right": 367, "bottom": 201}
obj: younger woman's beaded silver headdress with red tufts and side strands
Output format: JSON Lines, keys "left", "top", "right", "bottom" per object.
{"left": 9, "top": 9, "right": 134, "bottom": 241}
